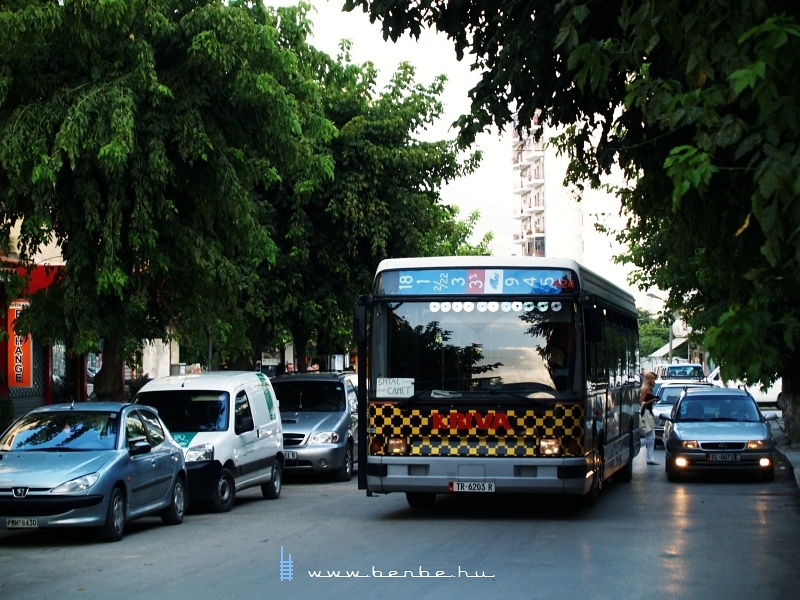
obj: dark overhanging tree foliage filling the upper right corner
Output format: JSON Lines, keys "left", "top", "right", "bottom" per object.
{"left": 345, "top": 0, "right": 800, "bottom": 441}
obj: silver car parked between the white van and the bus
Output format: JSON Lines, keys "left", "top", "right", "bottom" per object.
{"left": 272, "top": 373, "right": 358, "bottom": 481}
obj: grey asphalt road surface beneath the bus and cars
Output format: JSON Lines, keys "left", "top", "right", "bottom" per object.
{"left": 0, "top": 450, "right": 800, "bottom": 600}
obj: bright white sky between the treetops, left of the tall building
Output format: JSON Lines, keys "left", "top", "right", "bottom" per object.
{"left": 267, "top": 0, "right": 519, "bottom": 255}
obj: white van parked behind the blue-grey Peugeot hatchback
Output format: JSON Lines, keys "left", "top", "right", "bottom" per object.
{"left": 134, "top": 371, "right": 284, "bottom": 512}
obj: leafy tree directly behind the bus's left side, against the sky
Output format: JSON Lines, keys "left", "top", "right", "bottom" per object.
{"left": 228, "top": 42, "right": 484, "bottom": 369}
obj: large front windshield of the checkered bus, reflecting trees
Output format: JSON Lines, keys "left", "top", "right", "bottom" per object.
{"left": 371, "top": 297, "right": 580, "bottom": 399}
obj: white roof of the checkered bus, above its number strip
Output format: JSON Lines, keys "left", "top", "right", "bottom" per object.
{"left": 377, "top": 256, "right": 636, "bottom": 316}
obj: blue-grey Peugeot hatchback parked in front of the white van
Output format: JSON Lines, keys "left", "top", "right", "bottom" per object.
{"left": 0, "top": 402, "right": 187, "bottom": 541}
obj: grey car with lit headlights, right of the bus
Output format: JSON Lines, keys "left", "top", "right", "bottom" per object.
{"left": 664, "top": 386, "right": 778, "bottom": 481}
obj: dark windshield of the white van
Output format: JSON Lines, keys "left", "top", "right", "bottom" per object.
{"left": 136, "top": 390, "right": 230, "bottom": 433}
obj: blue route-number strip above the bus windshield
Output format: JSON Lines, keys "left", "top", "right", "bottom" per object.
{"left": 376, "top": 268, "right": 578, "bottom": 296}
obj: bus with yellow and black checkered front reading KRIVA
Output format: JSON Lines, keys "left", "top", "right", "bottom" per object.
{"left": 355, "top": 256, "right": 640, "bottom": 507}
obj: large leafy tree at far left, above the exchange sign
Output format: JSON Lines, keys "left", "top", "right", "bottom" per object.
{"left": 0, "top": 0, "right": 334, "bottom": 398}
